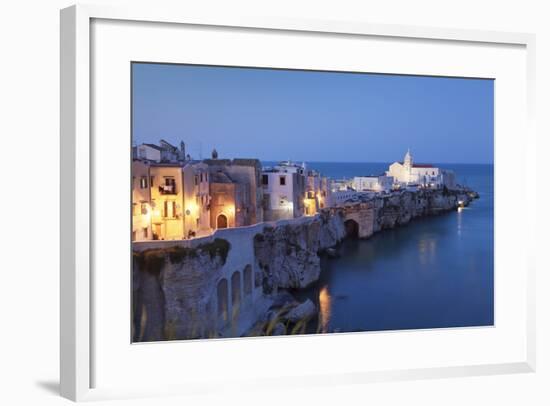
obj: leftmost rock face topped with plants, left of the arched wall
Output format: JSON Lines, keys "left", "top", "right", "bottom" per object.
{"left": 133, "top": 239, "right": 230, "bottom": 341}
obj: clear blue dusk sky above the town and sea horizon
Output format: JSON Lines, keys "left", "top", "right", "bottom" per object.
{"left": 132, "top": 63, "right": 494, "bottom": 163}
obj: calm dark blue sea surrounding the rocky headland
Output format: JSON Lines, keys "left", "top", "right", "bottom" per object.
{"left": 284, "top": 163, "right": 493, "bottom": 332}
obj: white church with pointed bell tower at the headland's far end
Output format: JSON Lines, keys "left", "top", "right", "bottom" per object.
{"left": 386, "top": 151, "right": 456, "bottom": 189}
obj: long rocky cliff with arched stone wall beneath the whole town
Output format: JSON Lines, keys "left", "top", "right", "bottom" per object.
{"left": 132, "top": 190, "right": 476, "bottom": 341}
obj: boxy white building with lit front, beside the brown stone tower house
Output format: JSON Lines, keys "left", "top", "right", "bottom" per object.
{"left": 261, "top": 161, "right": 306, "bottom": 221}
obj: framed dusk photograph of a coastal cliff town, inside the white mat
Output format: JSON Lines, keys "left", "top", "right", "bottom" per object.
{"left": 133, "top": 62, "right": 500, "bottom": 343}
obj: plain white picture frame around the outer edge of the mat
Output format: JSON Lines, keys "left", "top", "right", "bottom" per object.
{"left": 60, "top": 5, "right": 535, "bottom": 401}
